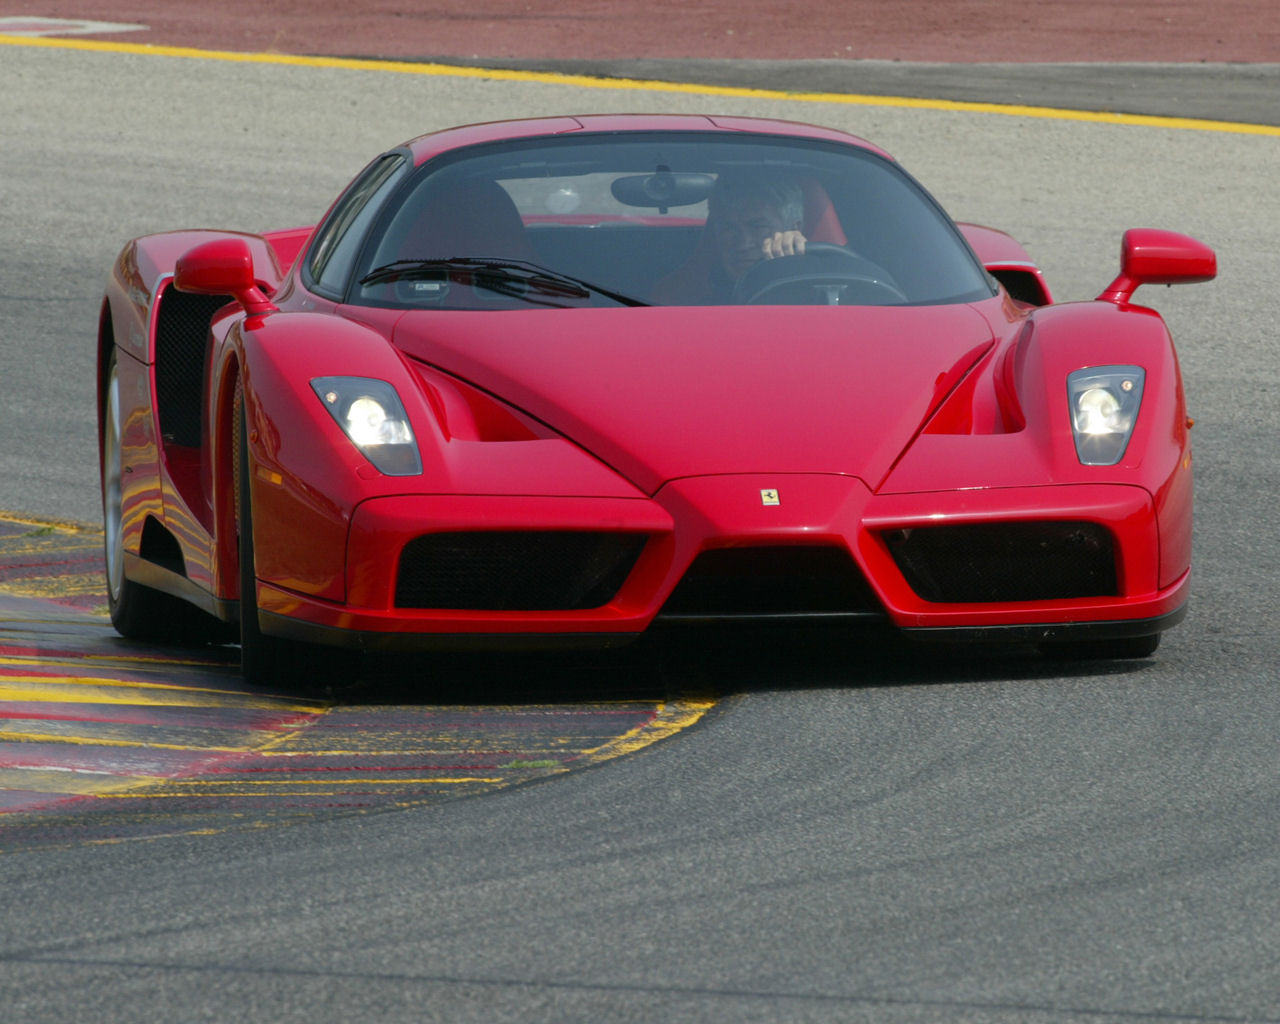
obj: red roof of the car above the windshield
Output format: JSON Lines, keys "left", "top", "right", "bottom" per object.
{"left": 396, "top": 114, "right": 892, "bottom": 165}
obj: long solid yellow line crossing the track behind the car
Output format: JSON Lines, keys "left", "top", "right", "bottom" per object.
{"left": 0, "top": 35, "right": 1280, "bottom": 137}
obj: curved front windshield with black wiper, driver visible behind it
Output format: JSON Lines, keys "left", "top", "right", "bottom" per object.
{"left": 347, "top": 132, "right": 993, "bottom": 310}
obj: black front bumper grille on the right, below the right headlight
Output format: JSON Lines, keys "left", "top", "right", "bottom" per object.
{"left": 883, "top": 521, "right": 1117, "bottom": 604}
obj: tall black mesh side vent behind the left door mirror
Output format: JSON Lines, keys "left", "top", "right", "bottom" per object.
{"left": 156, "top": 287, "right": 232, "bottom": 448}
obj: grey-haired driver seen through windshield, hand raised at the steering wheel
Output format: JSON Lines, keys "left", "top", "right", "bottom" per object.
{"left": 653, "top": 172, "right": 805, "bottom": 306}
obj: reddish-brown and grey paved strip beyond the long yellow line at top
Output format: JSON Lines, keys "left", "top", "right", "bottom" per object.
{"left": 0, "top": 0, "right": 1280, "bottom": 124}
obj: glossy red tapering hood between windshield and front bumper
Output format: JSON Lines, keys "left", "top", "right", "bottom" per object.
{"left": 394, "top": 305, "right": 993, "bottom": 494}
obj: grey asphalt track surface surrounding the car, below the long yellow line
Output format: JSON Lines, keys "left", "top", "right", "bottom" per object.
{"left": 0, "top": 4, "right": 1280, "bottom": 1024}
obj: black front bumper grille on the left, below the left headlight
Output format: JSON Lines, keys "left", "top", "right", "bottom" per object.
{"left": 396, "top": 530, "right": 645, "bottom": 612}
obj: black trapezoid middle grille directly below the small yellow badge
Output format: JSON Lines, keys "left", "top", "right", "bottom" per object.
{"left": 662, "top": 547, "right": 883, "bottom": 620}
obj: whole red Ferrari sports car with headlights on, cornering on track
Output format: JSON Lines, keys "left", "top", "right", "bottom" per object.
{"left": 97, "top": 115, "right": 1216, "bottom": 678}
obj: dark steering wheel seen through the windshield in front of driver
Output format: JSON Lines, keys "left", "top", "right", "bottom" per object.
{"left": 733, "top": 242, "right": 906, "bottom": 306}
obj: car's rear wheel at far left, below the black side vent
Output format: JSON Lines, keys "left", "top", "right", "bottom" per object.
{"left": 101, "top": 351, "right": 223, "bottom": 644}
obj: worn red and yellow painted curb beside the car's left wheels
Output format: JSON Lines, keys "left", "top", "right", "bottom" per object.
{"left": 0, "top": 515, "right": 714, "bottom": 850}
